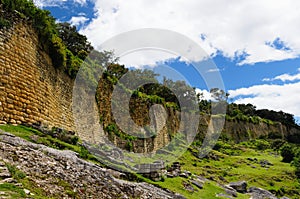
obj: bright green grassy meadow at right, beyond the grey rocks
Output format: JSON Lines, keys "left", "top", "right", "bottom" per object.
{"left": 180, "top": 142, "right": 300, "bottom": 198}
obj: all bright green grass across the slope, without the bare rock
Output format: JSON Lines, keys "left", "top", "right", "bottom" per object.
{"left": 0, "top": 125, "right": 300, "bottom": 199}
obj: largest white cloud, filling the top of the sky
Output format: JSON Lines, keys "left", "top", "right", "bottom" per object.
{"left": 81, "top": 0, "right": 300, "bottom": 65}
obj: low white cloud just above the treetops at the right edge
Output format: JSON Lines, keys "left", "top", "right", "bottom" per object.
{"left": 228, "top": 82, "right": 300, "bottom": 117}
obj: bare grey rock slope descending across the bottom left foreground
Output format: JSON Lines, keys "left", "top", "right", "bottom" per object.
{"left": 0, "top": 132, "right": 182, "bottom": 199}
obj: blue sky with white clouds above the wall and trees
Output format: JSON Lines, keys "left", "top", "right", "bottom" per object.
{"left": 34, "top": 0, "right": 300, "bottom": 120}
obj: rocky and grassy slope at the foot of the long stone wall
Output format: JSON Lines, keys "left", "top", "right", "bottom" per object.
{"left": 0, "top": 125, "right": 300, "bottom": 199}
